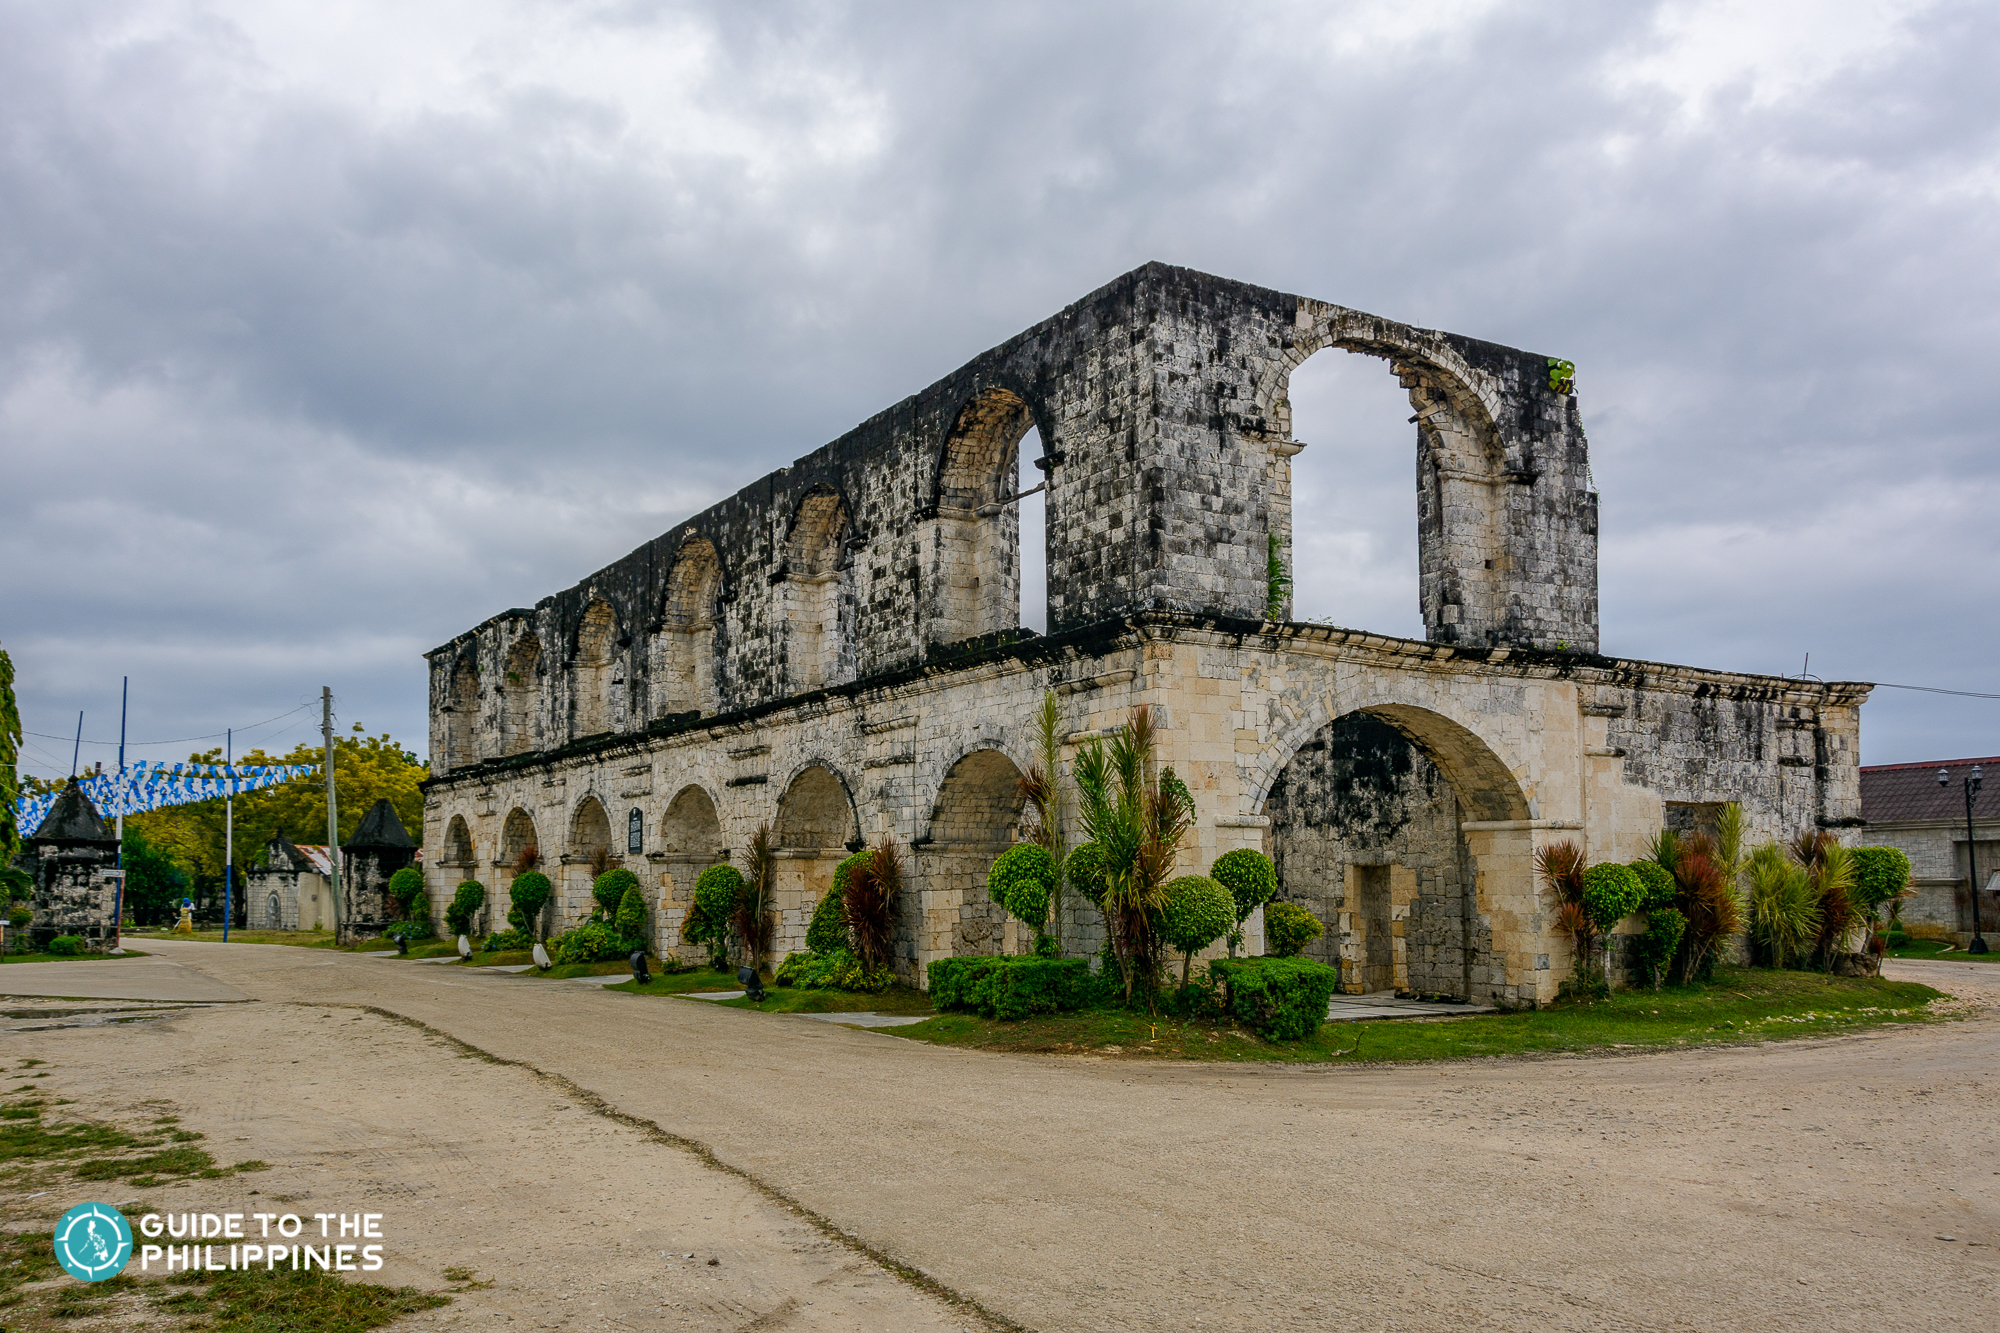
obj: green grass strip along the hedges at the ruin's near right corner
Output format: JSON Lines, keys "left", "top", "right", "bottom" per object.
{"left": 884, "top": 967, "right": 1940, "bottom": 1063}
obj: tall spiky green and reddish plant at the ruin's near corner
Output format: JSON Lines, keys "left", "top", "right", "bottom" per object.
{"left": 1072, "top": 705, "right": 1194, "bottom": 1009}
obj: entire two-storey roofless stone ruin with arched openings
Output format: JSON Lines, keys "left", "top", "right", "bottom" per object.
{"left": 422, "top": 264, "right": 1868, "bottom": 1003}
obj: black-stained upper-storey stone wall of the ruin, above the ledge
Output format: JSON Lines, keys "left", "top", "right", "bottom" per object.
{"left": 430, "top": 264, "right": 1598, "bottom": 773}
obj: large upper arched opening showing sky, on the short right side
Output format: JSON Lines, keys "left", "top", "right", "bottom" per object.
{"left": 1280, "top": 348, "right": 1424, "bottom": 638}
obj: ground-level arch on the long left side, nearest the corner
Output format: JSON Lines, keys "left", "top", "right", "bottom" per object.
{"left": 918, "top": 751, "right": 1032, "bottom": 955}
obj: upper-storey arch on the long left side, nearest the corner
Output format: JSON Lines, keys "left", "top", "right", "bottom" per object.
{"left": 928, "top": 388, "right": 1046, "bottom": 644}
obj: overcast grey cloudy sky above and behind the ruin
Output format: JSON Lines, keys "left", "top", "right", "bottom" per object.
{"left": 0, "top": 0, "right": 2000, "bottom": 775}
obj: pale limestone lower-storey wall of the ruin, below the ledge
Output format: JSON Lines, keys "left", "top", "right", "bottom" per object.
{"left": 424, "top": 614, "right": 1862, "bottom": 1003}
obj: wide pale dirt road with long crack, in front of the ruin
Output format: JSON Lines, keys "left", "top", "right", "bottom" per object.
{"left": 14, "top": 943, "right": 2000, "bottom": 1333}
